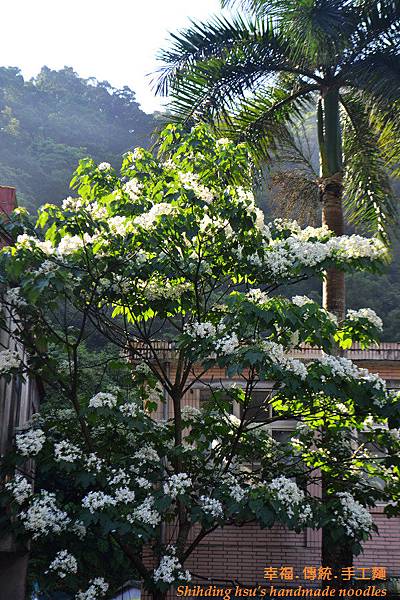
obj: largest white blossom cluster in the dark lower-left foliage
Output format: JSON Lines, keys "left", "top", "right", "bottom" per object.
{"left": 19, "top": 491, "right": 71, "bottom": 539}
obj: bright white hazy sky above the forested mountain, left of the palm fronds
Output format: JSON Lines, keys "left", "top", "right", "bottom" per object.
{"left": 0, "top": 0, "right": 225, "bottom": 112}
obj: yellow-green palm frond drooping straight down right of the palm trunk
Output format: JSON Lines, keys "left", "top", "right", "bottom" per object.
{"left": 341, "top": 92, "right": 398, "bottom": 240}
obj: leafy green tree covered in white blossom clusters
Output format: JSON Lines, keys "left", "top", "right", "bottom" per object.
{"left": 0, "top": 126, "right": 399, "bottom": 600}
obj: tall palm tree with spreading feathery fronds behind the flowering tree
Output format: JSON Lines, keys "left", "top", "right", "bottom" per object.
{"left": 157, "top": 0, "right": 400, "bottom": 318}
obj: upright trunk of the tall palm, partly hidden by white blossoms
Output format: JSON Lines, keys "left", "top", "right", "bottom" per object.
{"left": 318, "top": 89, "right": 353, "bottom": 588}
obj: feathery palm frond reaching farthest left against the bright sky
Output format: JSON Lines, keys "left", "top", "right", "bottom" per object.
{"left": 161, "top": 16, "right": 312, "bottom": 119}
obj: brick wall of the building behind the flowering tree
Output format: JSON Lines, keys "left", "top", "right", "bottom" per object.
{"left": 143, "top": 343, "right": 400, "bottom": 598}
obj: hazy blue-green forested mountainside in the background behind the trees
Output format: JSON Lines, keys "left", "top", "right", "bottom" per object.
{"left": 0, "top": 67, "right": 400, "bottom": 341}
